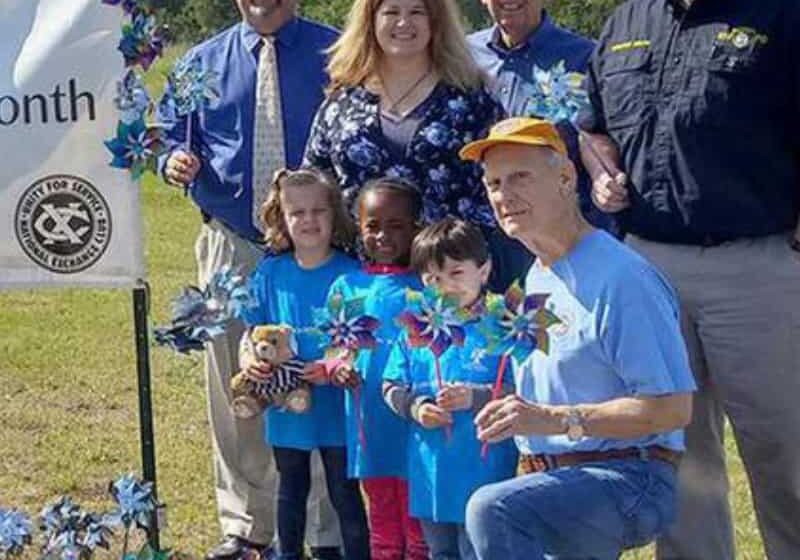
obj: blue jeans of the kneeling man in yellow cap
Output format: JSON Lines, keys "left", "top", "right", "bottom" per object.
{"left": 467, "top": 459, "right": 676, "bottom": 560}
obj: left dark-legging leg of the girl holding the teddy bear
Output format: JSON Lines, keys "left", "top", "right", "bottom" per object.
{"left": 272, "top": 447, "right": 311, "bottom": 560}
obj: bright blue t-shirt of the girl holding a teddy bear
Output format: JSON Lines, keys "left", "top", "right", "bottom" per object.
{"left": 244, "top": 251, "right": 358, "bottom": 450}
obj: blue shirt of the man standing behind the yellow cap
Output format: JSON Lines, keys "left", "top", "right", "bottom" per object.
{"left": 468, "top": 12, "right": 617, "bottom": 233}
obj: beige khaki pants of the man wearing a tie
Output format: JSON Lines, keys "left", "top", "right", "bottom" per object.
{"left": 195, "top": 220, "right": 341, "bottom": 547}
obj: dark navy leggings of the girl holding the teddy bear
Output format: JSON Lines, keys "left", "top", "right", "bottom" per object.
{"left": 272, "top": 447, "right": 369, "bottom": 560}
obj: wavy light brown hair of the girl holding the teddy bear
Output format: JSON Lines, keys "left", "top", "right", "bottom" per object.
{"left": 258, "top": 167, "right": 356, "bottom": 253}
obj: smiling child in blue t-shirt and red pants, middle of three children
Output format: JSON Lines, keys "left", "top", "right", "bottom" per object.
{"left": 324, "top": 178, "right": 428, "bottom": 560}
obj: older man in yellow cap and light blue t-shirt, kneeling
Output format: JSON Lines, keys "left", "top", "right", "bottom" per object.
{"left": 461, "top": 118, "right": 695, "bottom": 560}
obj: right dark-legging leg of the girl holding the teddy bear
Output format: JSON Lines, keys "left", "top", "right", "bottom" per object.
{"left": 319, "top": 447, "right": 370, "bottom": 560}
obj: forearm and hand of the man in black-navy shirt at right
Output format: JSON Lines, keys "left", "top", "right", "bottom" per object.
{"left": 580, "top": 132, "right": 630, "bottom": 213}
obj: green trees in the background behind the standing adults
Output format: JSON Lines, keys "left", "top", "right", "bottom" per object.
{"left": 153, "top": 0, "right": 622, "bottom": 47}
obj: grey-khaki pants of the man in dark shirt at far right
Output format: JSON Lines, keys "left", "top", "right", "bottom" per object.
{"left": 627, "top": 235, "right": 800, "bottom": 560}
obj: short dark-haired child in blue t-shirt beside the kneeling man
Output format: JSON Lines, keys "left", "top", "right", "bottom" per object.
{"left": 384, "top": 218, "right": 517, "bottom": 560}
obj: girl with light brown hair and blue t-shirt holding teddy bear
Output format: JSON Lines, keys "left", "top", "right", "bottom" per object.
{"left": 246, "top": 169, "right": 369, "bottom": 560}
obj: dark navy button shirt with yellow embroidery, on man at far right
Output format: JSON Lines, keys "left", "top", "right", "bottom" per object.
{"left": 581, "top": 0, "right": 800, "bottom": 245}
